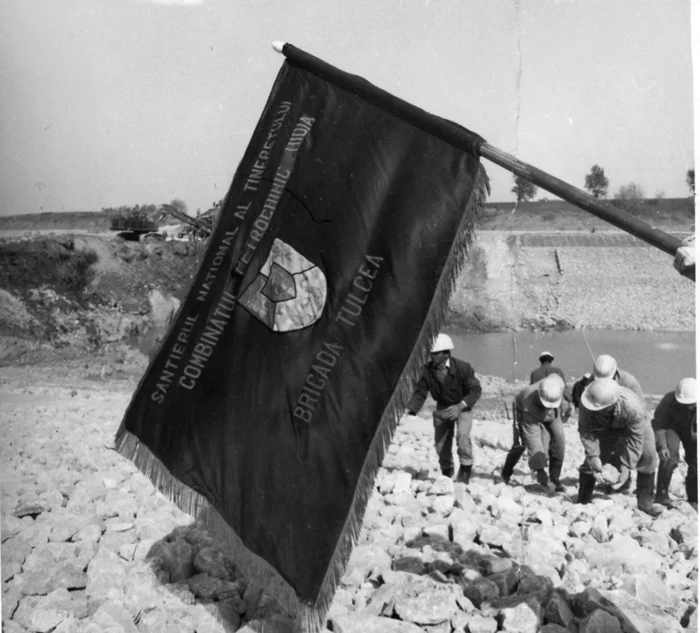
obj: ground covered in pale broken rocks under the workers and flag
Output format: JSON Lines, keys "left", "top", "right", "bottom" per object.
{"left": 0, "top": 354, "right": 698, "bottom": 633}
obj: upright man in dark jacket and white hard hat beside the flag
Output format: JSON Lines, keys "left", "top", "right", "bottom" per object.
{"left": 407, "top": 333, "right": 481, "bottom": 484}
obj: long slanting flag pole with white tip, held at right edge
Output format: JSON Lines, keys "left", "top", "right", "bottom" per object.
{"left": 272, "top": 42, "right": 695, "bottom": 281}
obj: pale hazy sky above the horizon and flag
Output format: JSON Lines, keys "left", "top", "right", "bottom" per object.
{"left": 0, "top": 0, "right": 693, "bottom": 214}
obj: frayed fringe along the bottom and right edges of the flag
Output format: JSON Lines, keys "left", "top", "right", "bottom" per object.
{"left": 116, "top": 165, "right": 489, "bottom": 633}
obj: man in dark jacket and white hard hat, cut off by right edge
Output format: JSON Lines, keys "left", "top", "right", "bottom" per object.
{"left": 652, "top": 378, "right": 698, "bottom": 510}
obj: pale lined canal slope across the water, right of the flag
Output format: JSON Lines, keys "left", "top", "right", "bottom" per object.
{"left": 449, "top": 231, "right": 695, "bottom": 331}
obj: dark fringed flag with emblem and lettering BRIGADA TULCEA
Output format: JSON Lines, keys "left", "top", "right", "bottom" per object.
{"left": 116, "top": 45, "right": 488, "bottom": 630}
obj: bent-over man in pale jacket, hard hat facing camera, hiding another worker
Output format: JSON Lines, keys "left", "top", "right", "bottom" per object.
{"left": 578, "top": 378, "right": 663, "bottom": 516}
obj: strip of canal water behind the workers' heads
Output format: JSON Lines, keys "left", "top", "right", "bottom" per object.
{"left": 447, "top": 329, "right": 696, "bottom": 395}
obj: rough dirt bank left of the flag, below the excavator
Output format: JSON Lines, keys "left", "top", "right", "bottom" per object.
{"left": 0, "top": 235, "right": 204, "bottom": 363}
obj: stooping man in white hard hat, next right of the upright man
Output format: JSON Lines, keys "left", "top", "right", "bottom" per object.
{"left": 501, "top": 374, "right": 569, "bottom": 492}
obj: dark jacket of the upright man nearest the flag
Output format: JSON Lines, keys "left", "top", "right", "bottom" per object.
{"left": 407, "top": 356, "right": 481, "bottom": 415}
